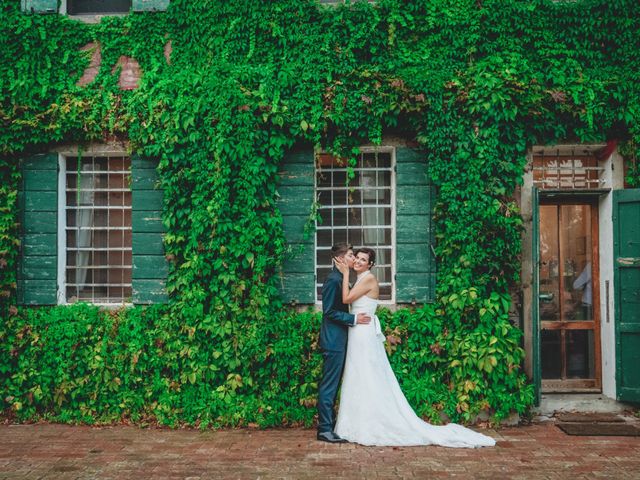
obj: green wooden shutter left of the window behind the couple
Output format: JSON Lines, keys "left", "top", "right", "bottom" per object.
{"left": 278, "top": 147, "right": 315, "bottom": 303}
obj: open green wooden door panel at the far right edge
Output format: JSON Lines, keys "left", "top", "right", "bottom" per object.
{"left": 613, "top": 189, "right": 640, "bottom": 402}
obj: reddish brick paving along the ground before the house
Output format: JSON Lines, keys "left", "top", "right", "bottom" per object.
{"left": 0, "top": 422, "right": 640, "bottom": 480}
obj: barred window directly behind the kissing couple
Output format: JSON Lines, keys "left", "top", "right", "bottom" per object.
{"left": 315, "top": 148, "right": 395, "bottom": 301}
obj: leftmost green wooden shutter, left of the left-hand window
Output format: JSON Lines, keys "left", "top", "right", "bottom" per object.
{"left": 17, "top": 153, "right": 58, "bottom": 305}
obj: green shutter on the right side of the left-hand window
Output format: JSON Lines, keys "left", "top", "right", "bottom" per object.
{"left": 131, "top": 156, "right": 169, "bottom": 304}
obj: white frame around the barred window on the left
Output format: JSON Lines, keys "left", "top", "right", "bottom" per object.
{"left": 56, "top": 152, "right": 133, "bottom": 308}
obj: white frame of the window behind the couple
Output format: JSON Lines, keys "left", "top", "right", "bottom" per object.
{"left": 313, "top": 145, "right": 397, "bottom": 307}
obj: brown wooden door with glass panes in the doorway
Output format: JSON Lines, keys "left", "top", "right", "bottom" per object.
{"left": 538, "top": 197, "right": 601, "bottom": 392}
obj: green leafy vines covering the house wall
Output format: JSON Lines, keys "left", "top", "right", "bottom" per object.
{"left": 0, "top": 0, "right": 640, "bottom": 426}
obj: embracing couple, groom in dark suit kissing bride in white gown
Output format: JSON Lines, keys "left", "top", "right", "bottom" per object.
{"left": 317, "top": 243, "right": 495, "bottom": 448}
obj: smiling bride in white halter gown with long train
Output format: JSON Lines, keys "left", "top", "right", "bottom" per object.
{"left": 335, "top": 248, "right": 495, "bottom": 447}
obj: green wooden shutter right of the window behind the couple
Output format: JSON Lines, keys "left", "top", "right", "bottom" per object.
{"left": 396, "top": 147, "right": 436, "bottom": 303}
